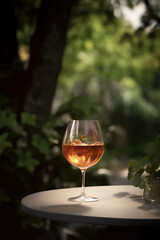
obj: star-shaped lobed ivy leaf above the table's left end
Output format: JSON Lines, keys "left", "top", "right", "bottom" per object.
{"left": 17, "top": 150, "right": 39, "bottom": 173}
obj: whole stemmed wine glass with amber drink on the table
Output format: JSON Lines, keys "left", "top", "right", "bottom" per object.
{"left": 62, "top": 120, "right": 104, "bottom": 202}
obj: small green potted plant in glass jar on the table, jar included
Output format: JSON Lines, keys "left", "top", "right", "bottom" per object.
{"left": 128, "top": 135, "right": 160, "bottom": 204}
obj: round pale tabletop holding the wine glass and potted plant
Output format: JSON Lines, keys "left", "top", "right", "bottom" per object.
{"left": 21, "top": 185, "right": 160, "bottom": 225}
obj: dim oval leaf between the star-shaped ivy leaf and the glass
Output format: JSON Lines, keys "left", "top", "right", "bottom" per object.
{"left": 32, "top": 134, "right": 50, "bottom": 154}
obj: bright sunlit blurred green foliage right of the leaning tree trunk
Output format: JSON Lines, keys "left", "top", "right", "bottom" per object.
{"left": 59, "top": 7, "right": 160, "bottom": 87}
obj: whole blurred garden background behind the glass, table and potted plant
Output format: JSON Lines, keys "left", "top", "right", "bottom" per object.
{"left": 0, "top": 0, "right": 160, "bottom": 239}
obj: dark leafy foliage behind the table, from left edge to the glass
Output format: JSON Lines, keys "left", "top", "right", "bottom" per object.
{"left": 0, "top": 98, "right": 108, "bottom": 240}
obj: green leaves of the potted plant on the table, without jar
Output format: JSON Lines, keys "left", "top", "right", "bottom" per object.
{"left": 128, "top": 135, "right": 160, "bottom": 188}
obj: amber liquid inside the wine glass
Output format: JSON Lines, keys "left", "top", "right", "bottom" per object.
{"left": 62, "top": 143, "right": 104, "bottom": 170}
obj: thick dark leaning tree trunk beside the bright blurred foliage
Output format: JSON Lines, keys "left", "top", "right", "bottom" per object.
{"left": 24, "top": 0, "right": 73, "bottom": 125}
